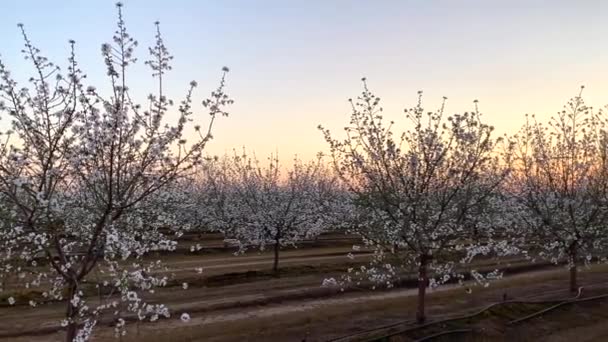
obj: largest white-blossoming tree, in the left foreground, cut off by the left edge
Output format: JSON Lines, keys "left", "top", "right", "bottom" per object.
{"left": 0, "top": 4, "right": 232, "bottom": 341}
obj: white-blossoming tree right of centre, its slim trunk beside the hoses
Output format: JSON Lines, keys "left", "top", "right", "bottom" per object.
{"left": 320, "top": 79, "right": 506, "bottom": 322}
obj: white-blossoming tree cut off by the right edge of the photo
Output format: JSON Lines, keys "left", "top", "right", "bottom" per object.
{"left": 506, "top": 89, "right": 608, "bottom": 291}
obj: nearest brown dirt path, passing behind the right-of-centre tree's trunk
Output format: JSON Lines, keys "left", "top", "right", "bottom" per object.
{"left": 0, "top": 268, "right": 608, "bottom": 342}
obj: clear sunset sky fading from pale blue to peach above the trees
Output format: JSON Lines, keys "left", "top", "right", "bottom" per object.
{"left": 0, "top": 0, "right": 608, "bottom": 159}
